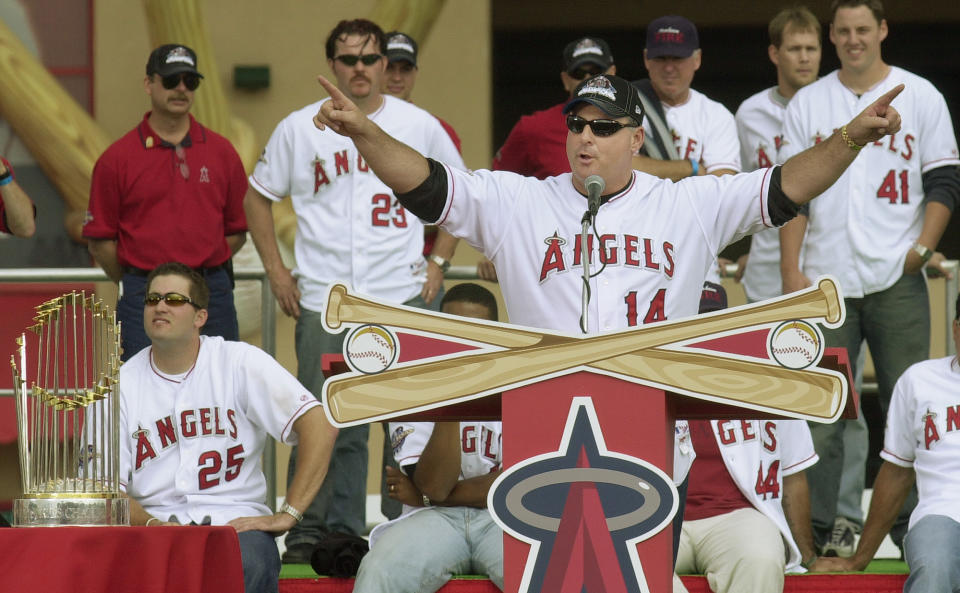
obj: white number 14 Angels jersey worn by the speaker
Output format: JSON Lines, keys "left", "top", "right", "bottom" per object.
{"left": 439, "top": 167, "right": 771, "bottom": 333}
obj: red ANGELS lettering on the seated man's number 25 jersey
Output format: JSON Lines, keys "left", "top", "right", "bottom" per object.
{"left": 130, "top": 407, "right": 238, "bottom": 471}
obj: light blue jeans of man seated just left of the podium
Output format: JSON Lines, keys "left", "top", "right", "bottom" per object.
{"left": 353, "top": 507, "right": 503, "bottom": 593}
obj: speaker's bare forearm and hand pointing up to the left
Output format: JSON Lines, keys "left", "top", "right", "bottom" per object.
{"left": 313, "top": 76, "right": 430, "bottom": 193}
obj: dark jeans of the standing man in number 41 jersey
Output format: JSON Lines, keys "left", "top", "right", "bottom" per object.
{"left": 806, "top": 275, "right": 930, "bottom": 544}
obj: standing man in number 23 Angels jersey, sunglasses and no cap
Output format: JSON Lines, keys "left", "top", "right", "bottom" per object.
{"left": 244, "top": 19, "right": 464, "bottom": 563}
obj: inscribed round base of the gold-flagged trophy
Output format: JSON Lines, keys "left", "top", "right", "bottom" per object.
{"left": 13, "top": 495, "right": 130, "bottom": 527}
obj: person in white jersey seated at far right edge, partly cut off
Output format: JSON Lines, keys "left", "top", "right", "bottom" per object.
{"left": 829, "top": 297, "right": 960, "bottom": 593}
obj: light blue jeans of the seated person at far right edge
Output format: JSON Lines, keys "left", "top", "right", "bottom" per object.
{"left": 903, "top": 515, "right": 960, "bottom": 593}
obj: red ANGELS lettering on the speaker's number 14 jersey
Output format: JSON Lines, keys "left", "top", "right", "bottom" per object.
{"left": 540, "top": 231, "right": 676, "bottom": 283}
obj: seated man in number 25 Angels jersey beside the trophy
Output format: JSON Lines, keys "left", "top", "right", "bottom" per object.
{"left": 119, "top": 263, "right": 337, "bottom": 593}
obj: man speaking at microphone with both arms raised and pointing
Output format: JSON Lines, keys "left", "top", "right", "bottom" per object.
{"left": 313, "top": 68, "right": 903, "bottom": 584}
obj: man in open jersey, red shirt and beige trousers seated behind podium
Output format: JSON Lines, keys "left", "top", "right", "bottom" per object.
{"left": 674, "top": 420, "right": 819, "bottom": 593}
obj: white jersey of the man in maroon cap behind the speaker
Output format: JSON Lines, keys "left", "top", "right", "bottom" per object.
{"left": 643, "top": 89, "right": 740, "bottom": 284}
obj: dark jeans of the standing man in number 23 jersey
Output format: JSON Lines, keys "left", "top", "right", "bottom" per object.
{"left": 284, "top": 295, "right": 424, "bottom": 548}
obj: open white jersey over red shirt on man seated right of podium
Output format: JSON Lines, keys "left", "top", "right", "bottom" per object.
{"left": 710, "top": 420, "right": 819, "bottom": 572}
